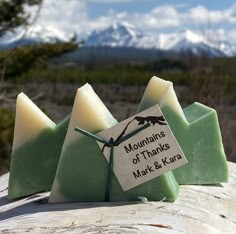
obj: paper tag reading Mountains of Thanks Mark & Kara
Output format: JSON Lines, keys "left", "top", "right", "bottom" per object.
{"left": 97, "top": 105, "right": 187, "bottom": 191}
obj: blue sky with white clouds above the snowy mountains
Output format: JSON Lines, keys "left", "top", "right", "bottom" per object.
{"left": 26, "top": 0, "right": 236, "bottom": 42}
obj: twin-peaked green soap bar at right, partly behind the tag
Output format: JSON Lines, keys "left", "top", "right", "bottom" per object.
{"left": 139, "top": 77, "right": 228, "bottom": 184}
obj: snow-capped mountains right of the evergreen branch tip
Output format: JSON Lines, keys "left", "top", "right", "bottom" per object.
{"left": 86, "top": 23, "right": 236, "bottom": 57}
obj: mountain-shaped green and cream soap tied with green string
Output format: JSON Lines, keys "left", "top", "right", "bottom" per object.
{"left": 49, "top": 84, "right": 179, "bottom": 203}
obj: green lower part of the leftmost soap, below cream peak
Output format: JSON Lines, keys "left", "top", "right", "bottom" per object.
{"left": 8, "top": 116, "right": 70, "bottom": 199}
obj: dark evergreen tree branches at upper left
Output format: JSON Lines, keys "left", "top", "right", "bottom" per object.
{"left": 0, "top": 0, "right": 78, "bottom": 80}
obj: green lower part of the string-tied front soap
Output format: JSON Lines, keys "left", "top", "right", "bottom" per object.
{"left": 52, "top": 129, "right": 179, "bottom": 202}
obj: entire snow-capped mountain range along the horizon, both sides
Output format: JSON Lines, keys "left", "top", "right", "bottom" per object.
{"left": 0, "top": 22, "right": 236, "bottom": 57}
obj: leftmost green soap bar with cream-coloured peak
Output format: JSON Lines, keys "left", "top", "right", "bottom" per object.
{"left": 8, "top": 93, "right": 70, "bottom": 199}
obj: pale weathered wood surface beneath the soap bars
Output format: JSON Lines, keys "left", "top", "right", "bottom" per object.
{"left": 0, "top": 163, "right": 236, "bottom": 234}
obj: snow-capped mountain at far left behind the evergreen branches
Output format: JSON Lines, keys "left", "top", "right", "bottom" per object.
{"left": 0, "top": 25, "right": 69, "bottom": 48}
